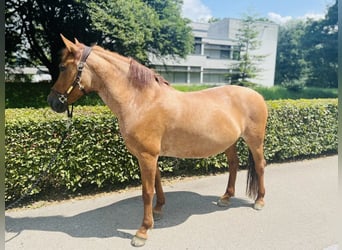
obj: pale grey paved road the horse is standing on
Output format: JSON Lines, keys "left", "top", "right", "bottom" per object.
{"left": 5, "top": 156, "right": 338, "bottom": 250}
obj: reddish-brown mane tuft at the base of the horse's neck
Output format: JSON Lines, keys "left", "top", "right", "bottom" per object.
{"left": 129, "top": 59, "right": 169, "bottom": 87}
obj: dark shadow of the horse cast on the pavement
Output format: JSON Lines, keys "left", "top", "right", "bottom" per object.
{"left": 5, "top": 192, "right": 253, "bottom": 241}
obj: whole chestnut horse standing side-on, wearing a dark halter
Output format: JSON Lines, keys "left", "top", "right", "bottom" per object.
{"left": 48, "top": 35, "right": 267, "bottom": 246}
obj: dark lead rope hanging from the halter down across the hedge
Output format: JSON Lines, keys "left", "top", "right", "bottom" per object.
{"left": 5, "top": 104, "right": 74, "bottom": 210}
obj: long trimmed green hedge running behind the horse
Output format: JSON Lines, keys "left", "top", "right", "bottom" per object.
{"left": 5, "top": 99, "right": 338, "bottom": 201}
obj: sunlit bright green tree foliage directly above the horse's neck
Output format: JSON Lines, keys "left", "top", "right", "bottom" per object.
{"left": 88, "top": 0, "right": 193, "bottom": 64}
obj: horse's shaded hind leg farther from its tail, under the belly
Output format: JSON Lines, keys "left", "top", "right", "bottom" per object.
{"left": 217, "top": 143, "right": 239, "bottom": 207}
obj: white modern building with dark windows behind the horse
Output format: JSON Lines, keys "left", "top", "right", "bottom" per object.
{"left": 150, "top": 18, "right": 278, "bottom": 86}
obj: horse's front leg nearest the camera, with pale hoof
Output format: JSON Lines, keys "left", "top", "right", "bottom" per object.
{"left": 131, "top": 155, "right": 158, "bottom": 246}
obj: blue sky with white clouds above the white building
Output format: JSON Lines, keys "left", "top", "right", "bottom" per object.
{"left": 182, "top": 0, "right": 335, "bottom": 24}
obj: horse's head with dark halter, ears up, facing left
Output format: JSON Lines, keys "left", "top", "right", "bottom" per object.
{"left": 48, "top": 35, "right": 91, "bottom": 113}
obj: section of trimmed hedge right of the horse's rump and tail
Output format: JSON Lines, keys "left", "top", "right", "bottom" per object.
{"left": 265, "top": 99, "right": 338, "bottom": 161}
